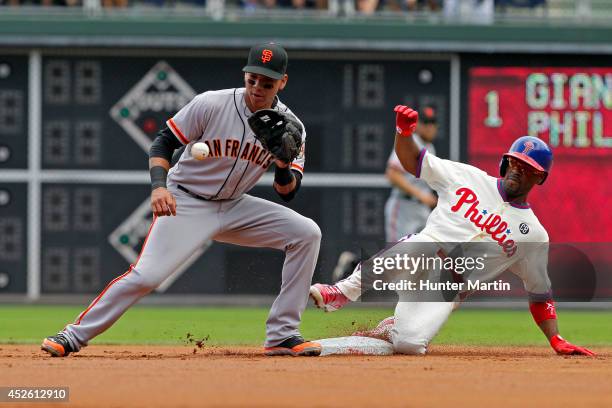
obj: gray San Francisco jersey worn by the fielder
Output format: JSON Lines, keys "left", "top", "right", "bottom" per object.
{"left": 166, "top": 88, "right": 306, "bottom": 200}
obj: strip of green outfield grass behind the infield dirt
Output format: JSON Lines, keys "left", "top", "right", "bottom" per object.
{"left": 0, "top": 305, "right": 612, "bottom": 345}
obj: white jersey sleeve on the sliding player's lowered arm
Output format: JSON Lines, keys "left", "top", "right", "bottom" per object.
{"left": 510, "top": 242, "right": 552, "bottom": 302}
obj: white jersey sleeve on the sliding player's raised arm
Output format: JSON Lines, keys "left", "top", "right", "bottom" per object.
{"left": 415, "top": 149, "right": 487, "bottom": 191}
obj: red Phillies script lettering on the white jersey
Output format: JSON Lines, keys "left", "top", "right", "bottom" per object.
{"left": 451, "top": 187, "right": 516, "bottom": 257}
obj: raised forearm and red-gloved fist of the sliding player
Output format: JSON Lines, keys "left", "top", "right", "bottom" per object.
{"left": 393, "top": 105, "right": 420, "bottom": 175}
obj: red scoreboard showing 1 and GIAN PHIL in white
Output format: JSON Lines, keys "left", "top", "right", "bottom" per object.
{"left": 467, "top": 66, "right": 612, "bottom": 242}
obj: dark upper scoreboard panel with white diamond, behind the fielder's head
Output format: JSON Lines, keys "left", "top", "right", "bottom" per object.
{"left": 38, "top": 52, "right": 450, "bottom": 173}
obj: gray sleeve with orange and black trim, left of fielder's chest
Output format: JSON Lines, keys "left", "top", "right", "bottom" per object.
{"left": 166, "top": 93, "right": 210, "bottom": 144}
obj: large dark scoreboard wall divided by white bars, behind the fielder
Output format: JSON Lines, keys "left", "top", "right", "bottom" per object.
{"left": 0, "top": 49, "right": 450, "bottom": 294}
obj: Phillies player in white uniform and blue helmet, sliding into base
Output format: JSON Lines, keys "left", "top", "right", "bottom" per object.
{"left": 310, "top": 105, "right": 594, "bottom": 356}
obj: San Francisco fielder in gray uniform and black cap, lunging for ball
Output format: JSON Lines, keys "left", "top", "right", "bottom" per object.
{"left": 42, "top": 44, "right": 321, "bottom": 356}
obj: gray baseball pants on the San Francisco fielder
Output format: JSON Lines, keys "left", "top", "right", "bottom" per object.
{"left": 64, "top": 189, "right": 321, "bottom": 351}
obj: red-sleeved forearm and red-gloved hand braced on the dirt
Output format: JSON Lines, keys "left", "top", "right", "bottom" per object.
{"left": 529, "top": 300, "right": 595, "bottom": 356}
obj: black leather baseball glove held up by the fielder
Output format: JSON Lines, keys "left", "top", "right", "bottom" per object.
{"left": 248, "top": 109, "right": 303, "bottom": 163}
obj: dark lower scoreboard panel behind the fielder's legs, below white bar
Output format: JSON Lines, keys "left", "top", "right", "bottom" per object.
{"left": 38, "top": 183, "right": 389, "bottom": 293}
